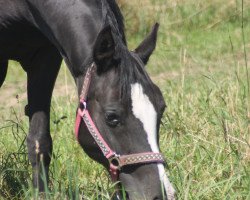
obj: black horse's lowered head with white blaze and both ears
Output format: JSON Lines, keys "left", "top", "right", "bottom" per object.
{"left": 77, "top": 24, "right": 174, "bottom": 200}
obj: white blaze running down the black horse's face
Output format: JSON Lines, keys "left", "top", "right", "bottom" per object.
{"left": 131, "top": 83, "right": 175, "bottom": 200}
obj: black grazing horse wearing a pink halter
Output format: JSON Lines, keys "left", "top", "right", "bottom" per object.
{"left": 0, "top": 0, "right": 174, "bottom": 200}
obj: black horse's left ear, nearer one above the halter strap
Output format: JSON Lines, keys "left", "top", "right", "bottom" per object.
{"left": 93, "top": 26, "right": 115, "bottom": 73}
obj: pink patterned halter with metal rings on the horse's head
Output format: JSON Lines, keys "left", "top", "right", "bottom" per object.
{"left": 75, "top": 63, "right": 164, "bottom": 182}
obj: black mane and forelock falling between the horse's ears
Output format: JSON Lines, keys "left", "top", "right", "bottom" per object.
{"left": 99, "top": 0, "right": 151, "bottom": 101}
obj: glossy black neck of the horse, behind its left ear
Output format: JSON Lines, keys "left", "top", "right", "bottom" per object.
{"left": 29, "top": 0, "right": 103, "bottom": 78}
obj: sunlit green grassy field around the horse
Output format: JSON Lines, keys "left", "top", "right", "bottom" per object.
{"left": 0, "top": 0, "right": 250, "bottom": 200}
